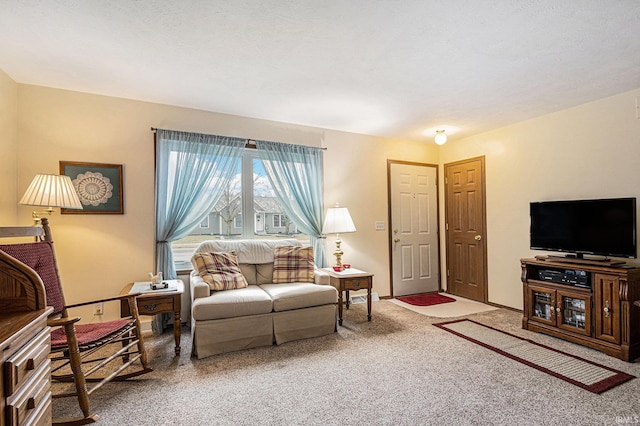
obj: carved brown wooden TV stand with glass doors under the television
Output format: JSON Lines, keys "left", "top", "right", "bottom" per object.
{"left": 520, "top": 258, "right": 640, "bottom": 361}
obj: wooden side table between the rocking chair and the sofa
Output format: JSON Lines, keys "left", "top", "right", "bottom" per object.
{"left": 120, "top": 280, "right": 184, "bottom": 356}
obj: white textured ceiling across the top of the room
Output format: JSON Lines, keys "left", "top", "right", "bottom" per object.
{"left": 0, "top": 0, "right": 640, "bottom": 143}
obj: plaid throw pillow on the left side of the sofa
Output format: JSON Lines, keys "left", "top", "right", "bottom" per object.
{"left": 192, "top": 251, "right": 247, "bottom": 291}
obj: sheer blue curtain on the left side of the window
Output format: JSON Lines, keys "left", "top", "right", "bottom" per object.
{"left": 156, "top": 129, "right": 247, "bottom": 279}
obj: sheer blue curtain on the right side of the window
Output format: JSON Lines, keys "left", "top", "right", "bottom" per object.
{"left": 256, "top": 141, "right": 327, "bottom": 267}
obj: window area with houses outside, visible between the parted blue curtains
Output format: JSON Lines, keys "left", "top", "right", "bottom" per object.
{"left": 172, "top": 149, "right": 309, "bottom": 270}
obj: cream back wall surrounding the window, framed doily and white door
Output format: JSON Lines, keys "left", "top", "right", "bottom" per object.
{"left": 11, "top": 84, "right": 438, "bottom": 319}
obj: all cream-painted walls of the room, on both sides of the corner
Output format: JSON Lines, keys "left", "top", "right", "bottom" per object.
{"left": 6, "top": 76, "right": 640, "bottom": 315}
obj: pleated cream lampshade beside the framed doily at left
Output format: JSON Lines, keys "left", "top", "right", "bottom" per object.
{"left": 20, "top": 175, "right": 82, "bottom": 210}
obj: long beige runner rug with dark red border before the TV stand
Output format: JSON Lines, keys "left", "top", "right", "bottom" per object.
{"left": 434, "top": 319, "right": 634, "bottom": 393}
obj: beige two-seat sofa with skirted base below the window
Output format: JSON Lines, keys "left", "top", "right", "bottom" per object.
{"left": 190, "top": 239, "right": 338, "bottom": 358}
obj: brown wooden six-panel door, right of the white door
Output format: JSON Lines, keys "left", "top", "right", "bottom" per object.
{"left": 444, "top": 157, "right": 487, "bottom": 302}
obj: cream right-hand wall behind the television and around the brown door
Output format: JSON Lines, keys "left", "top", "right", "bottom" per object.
{"left": 440, "top": 89, "right": 640, "bottom": 309}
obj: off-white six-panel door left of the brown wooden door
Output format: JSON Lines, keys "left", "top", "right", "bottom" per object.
{"left": 389, "top": 162, "right": 440, "bottom": 296}
